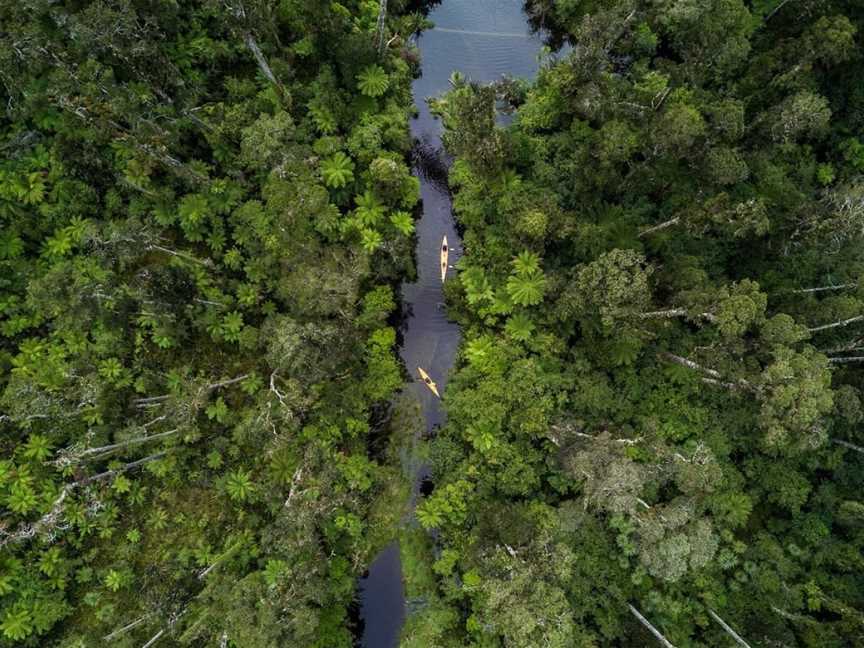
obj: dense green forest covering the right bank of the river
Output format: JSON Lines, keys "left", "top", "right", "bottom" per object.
{"left": 418, "top": 0, "right": 864, "bottom": 648}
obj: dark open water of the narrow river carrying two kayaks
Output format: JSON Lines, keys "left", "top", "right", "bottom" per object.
{"left": 360, "top": 0, "right": 542, "bottom": 648}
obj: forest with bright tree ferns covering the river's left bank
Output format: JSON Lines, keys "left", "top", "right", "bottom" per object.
{"left": 0, "top": 0, "right": 430, "bottom": 648}
